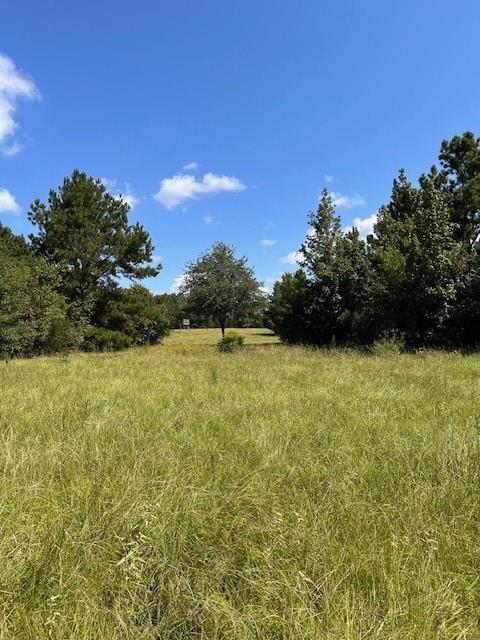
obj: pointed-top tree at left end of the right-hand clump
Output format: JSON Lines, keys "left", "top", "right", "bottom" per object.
{"left": 268, "top": 190, "right": 371, "bottom": 344}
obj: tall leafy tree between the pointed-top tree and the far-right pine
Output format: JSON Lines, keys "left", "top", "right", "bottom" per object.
{"left": 374, "top": 172, "right": 463, "bottom": 345}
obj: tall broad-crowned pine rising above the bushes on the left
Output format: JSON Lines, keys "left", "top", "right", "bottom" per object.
{"left": 28, "top": 170, "right": 159, "bottom": 316}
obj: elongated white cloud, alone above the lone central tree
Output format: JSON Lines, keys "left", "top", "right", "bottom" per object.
{"left": 153, "top": 173, "right": 246, "bottom": 209}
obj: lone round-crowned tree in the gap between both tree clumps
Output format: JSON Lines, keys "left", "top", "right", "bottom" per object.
{"left": 181, "top": 242, "right": 263, "bottom": 335}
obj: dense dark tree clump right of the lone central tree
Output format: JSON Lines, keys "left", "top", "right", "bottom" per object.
{"left": 269, "top": 132, "right": 480, "bottom": 348}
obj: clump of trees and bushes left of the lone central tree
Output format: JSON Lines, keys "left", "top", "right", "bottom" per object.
{"left": 0, "top": 171, "right": 168, "bottom": 355}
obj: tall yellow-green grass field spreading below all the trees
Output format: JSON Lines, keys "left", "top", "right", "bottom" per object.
{"left": 0, "top": 330, "right": 480, "bottom": 640}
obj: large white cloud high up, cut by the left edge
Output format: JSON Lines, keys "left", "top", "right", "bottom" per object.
{"left": 0, "top": 53, "right": 40, "bottom": 156}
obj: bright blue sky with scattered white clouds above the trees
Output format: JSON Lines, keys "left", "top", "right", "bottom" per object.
{"left": 0, "top": 0, "right": 480, "bottom": 291}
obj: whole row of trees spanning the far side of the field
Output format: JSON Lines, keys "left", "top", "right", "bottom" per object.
{"left": 0, "top": 132, "right": 480, "bottom": 356}
